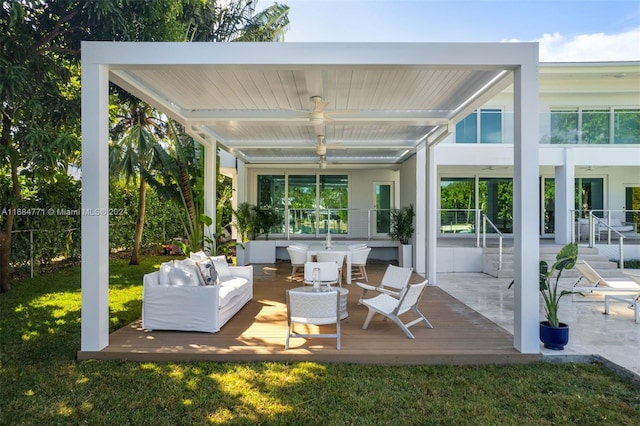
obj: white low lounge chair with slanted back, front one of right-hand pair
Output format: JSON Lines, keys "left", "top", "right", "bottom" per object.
{"left": 362, "top": 280, "right": 433, "bottom": 339}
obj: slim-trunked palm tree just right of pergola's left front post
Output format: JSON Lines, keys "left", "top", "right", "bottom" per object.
{"left": 109, "top": 98, "right": 164, "bottom": 265}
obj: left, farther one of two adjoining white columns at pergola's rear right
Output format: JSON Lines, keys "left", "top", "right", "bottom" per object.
{"left": 413, "top": 147, "right": 427, "bottom": 276}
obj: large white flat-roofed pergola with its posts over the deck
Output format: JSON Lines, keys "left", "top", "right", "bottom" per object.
{"left": 81, "top": 42, "right": 539, "bottom": 353}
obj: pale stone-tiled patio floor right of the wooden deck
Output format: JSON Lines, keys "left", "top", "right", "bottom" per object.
{"left": 437, "top": 273, "right": 640, "bottom": 380}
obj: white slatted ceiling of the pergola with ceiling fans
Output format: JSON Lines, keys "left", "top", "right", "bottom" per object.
{"left": 115, "top": 45, "right": 510, "bottom": 164}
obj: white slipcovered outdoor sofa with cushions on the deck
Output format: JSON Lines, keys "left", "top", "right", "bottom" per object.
{"left": 142, "top": 254, "right": 253, "bottom": 333}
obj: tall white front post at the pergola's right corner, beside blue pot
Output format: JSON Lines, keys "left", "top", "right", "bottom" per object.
{"left": 513, "top": 63, "right": 540, "bottom": 353}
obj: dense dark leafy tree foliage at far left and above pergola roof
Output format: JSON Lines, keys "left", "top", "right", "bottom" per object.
{"left": 0, "top": 0, "right": 289, "bottom": 292}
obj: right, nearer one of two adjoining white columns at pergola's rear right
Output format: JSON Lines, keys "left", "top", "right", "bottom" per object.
{"left": 425, "top": 145, "right": 440, "bottom": 284}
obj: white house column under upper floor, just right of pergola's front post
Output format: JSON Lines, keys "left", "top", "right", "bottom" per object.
{"left": 554, "top": 149, "right": 575, "bottom": 245}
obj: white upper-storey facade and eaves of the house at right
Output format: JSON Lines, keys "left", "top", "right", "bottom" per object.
{"left": 436, "top": 62, "right": 640, "bottom": 243}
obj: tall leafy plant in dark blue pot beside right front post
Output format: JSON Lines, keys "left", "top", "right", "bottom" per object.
{"left": 509, "top": 243, "right": 582, "bottom": 350}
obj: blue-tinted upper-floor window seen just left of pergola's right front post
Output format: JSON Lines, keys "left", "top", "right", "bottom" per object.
{"left": 456, "top": 109, "right": 502, "bottom": 143}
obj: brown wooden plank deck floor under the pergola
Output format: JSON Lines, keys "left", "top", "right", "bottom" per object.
{"left": 78, "top": 263, "right": 541, "bottom": 365}
